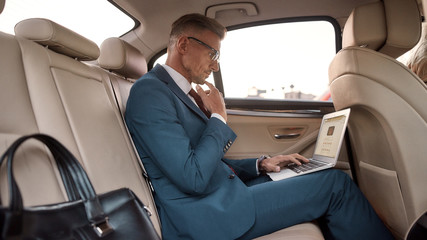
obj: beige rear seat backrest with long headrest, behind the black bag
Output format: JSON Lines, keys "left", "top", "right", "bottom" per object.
{"left": 0, "top": 19, "right": 160, "bottom": 234}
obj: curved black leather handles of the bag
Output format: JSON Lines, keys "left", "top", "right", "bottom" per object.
{"left": 0, "top": 134, "right": 112, "bottom": 235}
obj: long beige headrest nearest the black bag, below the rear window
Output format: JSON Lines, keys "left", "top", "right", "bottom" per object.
{"left": 15, "top": 18, "right": 99, "bottom": 61}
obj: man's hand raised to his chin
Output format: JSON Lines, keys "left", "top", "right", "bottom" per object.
{"left": 196, "top": 82, "right": 227, "bottom": 121}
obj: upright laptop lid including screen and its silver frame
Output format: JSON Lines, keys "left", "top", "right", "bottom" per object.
{"left": 313, "top": 109, "right": 350, "bottom": 164}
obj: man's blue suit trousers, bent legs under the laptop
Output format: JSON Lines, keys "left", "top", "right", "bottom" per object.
{"left": 239, "top": 170, "right": 393, "bottom": 240}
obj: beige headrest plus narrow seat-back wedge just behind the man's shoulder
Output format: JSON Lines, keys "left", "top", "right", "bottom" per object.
{"left": 98, "top": 37, "right": 147, "bottom": 114}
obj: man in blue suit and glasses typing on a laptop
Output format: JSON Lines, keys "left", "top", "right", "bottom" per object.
{"left": 126, "top": 14, "right": 392, "bottom": 240}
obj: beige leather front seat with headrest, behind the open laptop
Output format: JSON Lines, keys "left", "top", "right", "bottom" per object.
{"left": 329, "top": 0, "right": 427, "bottom": 239}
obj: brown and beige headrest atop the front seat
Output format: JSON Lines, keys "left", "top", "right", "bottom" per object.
{"left": 343, "top": 0, "right": 421, "bottom": 58}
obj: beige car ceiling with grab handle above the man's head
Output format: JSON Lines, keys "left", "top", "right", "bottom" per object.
{"left": 113, "top": 0, "right": 421, "bottom": 59}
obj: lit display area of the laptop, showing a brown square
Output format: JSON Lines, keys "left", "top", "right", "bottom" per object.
{"left": 314, "top": 115, "right": 346, "bottom": 158}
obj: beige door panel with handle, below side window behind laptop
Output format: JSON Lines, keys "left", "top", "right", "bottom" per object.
{"left": 225, "top": 110, "right": 351, "bottom": 175}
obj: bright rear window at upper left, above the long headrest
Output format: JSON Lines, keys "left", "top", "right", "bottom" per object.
{"left": 0, "top": 0, "right": 136, "bottom": 45}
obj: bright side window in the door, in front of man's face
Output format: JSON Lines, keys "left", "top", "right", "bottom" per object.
{"left": 220, "top": 21, "right": 337, "bottom": 100}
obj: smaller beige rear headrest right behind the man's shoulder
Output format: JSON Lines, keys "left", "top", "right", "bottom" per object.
{"left": 98, "top": 37, "right": 147, "bottom": 79}
